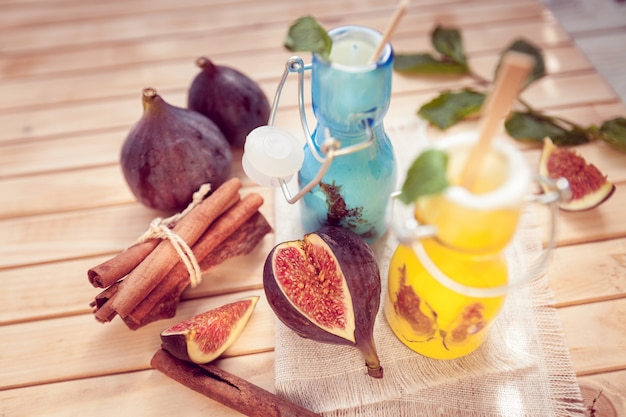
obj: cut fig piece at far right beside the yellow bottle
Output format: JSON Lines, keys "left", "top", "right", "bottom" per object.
{"left": 539, "top": 138, "right": 615, "bottom": 211}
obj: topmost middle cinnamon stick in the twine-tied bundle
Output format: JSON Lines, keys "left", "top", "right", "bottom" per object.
{"left": 111, "top": 178, "right": 242, "bottom": 317}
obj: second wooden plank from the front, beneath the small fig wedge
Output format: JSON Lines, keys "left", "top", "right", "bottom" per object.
{"left": 0, "top": 290, "right": 274, "bottom": 389}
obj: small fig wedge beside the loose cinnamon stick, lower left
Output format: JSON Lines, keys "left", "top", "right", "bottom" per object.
{"left": 161, "top": 296, "right": 259, "bottom": 364}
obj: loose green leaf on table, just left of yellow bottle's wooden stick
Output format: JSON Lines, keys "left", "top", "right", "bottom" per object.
{"left": 417, "top": 89, "right": 485, "bottom": 130}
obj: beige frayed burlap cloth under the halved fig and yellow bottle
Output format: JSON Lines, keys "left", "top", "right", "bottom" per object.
{"left": 275, "top": 122, "right": 584, "bottom": 417}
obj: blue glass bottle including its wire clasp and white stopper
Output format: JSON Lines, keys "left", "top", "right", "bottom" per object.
{"left": 242, "top": 26, "right": 397, "bottom": 243}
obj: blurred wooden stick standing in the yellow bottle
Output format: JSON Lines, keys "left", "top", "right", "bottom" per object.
{"left": 461, "top": 51, "right": 535, "bottom": 191}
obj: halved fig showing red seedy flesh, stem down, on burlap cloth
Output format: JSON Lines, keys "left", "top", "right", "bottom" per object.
{"left": 263, "top": 226, "right": 383, "bottom": 378}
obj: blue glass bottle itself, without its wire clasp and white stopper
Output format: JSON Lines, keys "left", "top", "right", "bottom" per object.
{"left": 298, "top": 26, "right": 397, "bottom": 243}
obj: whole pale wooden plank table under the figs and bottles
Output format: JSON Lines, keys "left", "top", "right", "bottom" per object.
{"left": 0, "top": 0, "right": 626, "bottom": 416}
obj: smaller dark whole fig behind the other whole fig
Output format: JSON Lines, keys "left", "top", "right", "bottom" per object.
{"left": 187, "top": 57, "right": 271, "bottom": 148}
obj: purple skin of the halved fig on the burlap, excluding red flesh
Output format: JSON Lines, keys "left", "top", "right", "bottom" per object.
{"left": 263, "top": 226, "right": 383, "bottom": 378}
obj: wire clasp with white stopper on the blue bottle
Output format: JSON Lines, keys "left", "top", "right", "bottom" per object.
{"left": 242, "top": 56, "right": 374, "bottom": 204}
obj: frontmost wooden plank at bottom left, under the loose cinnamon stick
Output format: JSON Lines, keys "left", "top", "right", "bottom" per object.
{"left": 0, "top": 352, "right": 274, "bottom": 417}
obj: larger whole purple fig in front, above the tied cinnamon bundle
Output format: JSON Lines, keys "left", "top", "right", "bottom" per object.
{"left": 120, "top": 88, "right": 232, "bottom": 212}
